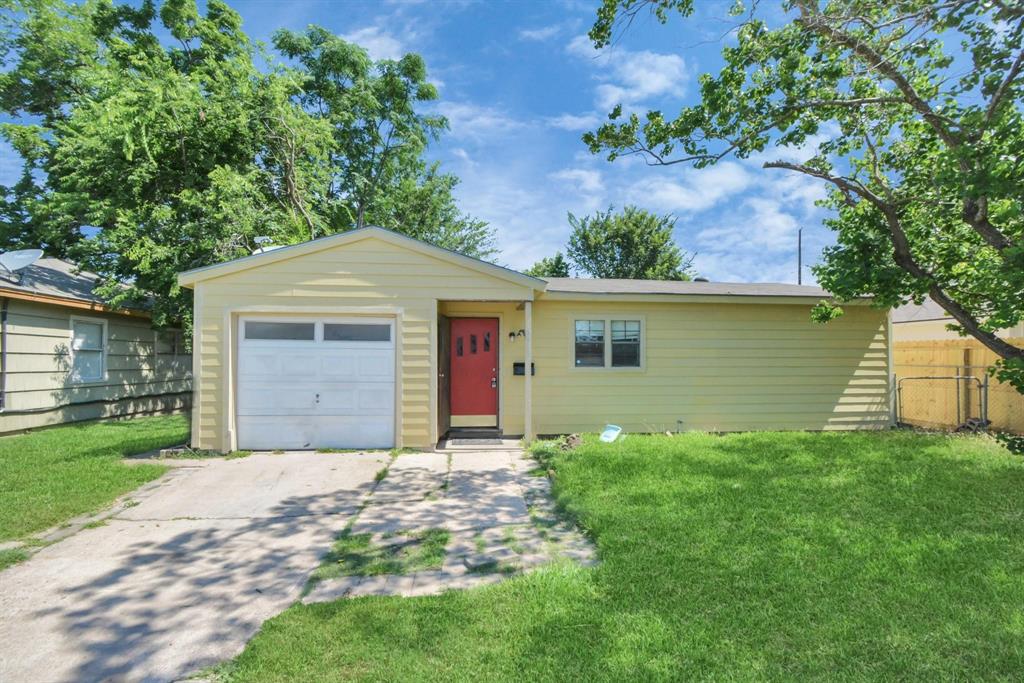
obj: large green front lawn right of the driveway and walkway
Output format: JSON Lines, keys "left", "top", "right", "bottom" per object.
{"left": 228, "top": 432, "right": 1024, "bottom": 681}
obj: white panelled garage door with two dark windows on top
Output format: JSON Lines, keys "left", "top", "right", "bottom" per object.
{"left": 236, "top": 318, "right": 394, "bottom": 450}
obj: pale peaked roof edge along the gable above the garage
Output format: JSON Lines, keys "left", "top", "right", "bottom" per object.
{"left": 178, "top": 225, "right": 547, "bottom": 292}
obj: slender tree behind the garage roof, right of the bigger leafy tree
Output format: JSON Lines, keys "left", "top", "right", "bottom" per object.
{"left": 273, "top": 26, "right": 495, "bottom": 258}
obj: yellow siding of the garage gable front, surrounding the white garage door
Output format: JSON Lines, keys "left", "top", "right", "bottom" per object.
{"left": 194, "top": 238, "right": 529, "bottom": 451}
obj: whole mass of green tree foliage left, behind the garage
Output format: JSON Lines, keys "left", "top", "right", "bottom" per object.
{"left": 0, "top": 0, "right": 494, "bottom": 326}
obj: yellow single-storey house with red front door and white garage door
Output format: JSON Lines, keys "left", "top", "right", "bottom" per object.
{"left": 179, "top": 227, "right": 890, "bottom": 451}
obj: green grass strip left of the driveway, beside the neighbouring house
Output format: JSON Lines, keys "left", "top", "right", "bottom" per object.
{"left": 0, "top": 416, "right": 188, "bottom": 541}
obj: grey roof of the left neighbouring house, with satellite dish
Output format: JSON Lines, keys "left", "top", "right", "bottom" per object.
{"left": 0, "top": 258, "right": 148, "bottom": 315}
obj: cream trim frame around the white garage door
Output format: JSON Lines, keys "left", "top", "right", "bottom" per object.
{"left": 226, "top": 305, "right": 406, "bottom": 451}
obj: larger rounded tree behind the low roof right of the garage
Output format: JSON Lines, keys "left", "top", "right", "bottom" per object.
{"left": 568, "top": 206, "right": 693, "bottom": 280}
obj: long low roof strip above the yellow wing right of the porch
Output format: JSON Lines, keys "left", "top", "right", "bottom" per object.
{"left": 546, "top": 278, "right": 828, "bottom": 299}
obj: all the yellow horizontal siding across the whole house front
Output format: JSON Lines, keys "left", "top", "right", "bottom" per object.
{"left": 194, "top": 232, "right": 890, "bottom": 450}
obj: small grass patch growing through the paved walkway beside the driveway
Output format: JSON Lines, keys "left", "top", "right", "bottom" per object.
{"left": 310, "top": 528, "right": 449, "bottom": 584}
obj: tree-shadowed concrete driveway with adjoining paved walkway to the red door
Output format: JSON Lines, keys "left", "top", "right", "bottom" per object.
{"left": 0, "top": 452, "right": 592, "bottom": 683}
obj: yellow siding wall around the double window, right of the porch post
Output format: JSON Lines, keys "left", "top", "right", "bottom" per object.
{"left": 534, "top": 298, "right": 889, "bottom": 434}
